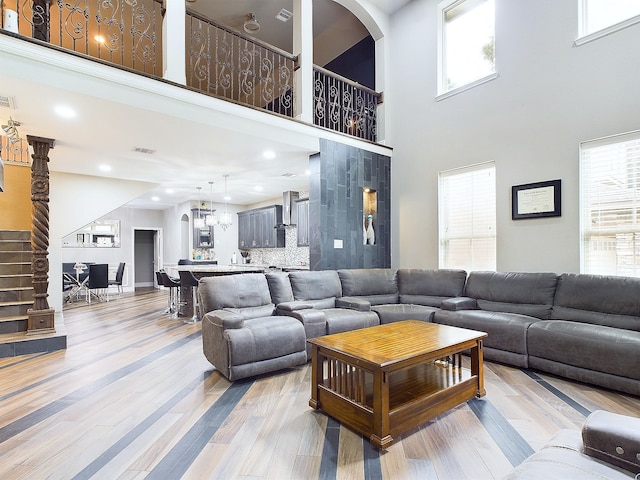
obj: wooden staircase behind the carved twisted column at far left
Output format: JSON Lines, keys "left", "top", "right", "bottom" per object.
{"left": 0, "top": 230, "right": 67, "bottom": 357}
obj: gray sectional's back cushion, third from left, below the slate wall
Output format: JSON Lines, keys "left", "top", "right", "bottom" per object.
{"left": 289, "top": 270, "right": 342, "bottom": 308}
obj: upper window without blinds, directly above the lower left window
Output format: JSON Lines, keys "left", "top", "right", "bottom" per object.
{"left": 438, "top": 0, "right": 496, "bottom": 95}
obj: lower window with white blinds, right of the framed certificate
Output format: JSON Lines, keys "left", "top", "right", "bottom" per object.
{"left": 580, "top": 131, "right": 640, "bottom": 277}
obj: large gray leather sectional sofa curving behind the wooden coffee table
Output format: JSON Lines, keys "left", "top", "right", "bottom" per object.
{"left": 198, "top": 269, "right": 640, "bottom": 396}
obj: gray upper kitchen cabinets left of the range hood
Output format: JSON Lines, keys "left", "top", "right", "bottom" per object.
{"left": 238, "top": 205, "right": 284, "bottom": 250}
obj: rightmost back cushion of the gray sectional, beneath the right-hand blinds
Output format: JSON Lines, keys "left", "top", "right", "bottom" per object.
{"left": 552, "top": 274, "right": 640, "bottom": 332}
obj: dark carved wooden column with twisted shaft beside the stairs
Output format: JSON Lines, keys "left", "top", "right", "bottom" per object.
{"left": 27, "top": 135, "right": 55, "bottom": 335}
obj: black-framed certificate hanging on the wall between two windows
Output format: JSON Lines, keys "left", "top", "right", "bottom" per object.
{"left": 511, "top": 180, "right": 561, "bottom": 220}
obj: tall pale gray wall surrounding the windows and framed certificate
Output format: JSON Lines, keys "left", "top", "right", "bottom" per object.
{"left": 385, "top": 0, "right": 640, "bottom": 272}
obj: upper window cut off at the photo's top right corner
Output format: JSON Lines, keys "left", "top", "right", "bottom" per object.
{"left": 576, "top": 0, "right": 640, "bottom": 45}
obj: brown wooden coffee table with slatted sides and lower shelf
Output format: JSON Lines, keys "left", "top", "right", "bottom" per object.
{"left": 308, "top": 320, "right": 487, "bottom": 449}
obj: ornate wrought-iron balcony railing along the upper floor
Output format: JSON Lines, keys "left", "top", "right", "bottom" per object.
{"left": 0, "top": 0, "right": 382, "bottom": 142}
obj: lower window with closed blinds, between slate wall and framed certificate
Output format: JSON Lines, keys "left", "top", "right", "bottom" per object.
{"left": 438, "top": 163, "right": 496, "bottom": 271}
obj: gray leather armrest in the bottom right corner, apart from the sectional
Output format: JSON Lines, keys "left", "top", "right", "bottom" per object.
{"left": 582, "top": 410, "right": 640, "bottom": 473}
